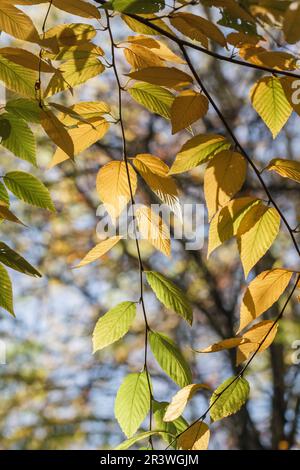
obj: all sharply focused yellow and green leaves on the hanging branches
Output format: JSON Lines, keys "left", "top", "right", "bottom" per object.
{"left": 0, "top": 0, "right": 300, "bottom": 450}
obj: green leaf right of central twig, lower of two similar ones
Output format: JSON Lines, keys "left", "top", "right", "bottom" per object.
{"left": 149, "top": 331, "right": 192, "bottom": 387}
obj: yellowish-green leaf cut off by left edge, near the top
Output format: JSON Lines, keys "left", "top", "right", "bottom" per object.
{"left": 0, "top": 55, "right": 38, "bottom": 99}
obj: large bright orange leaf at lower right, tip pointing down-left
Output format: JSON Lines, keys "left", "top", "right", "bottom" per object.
{"left": 238, "top": 269, "right": 293, "bottom": 333}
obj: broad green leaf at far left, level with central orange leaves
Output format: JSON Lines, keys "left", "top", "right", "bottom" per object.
{"left": 3, "top": 171, "right": 55, "bottom": 212}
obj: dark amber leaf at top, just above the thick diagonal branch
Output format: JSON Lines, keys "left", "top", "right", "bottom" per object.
{"left": 170, "top": 13, "right": 226, "bottom": 47}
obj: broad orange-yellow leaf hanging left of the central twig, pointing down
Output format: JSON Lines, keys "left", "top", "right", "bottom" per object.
{"left": 97, "top": 161, "right": 137, "bottom": 221}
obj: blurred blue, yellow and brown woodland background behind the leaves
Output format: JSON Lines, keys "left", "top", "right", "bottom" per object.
{"left": 0, "top": 5, "right": 300, "bottom": 449}
